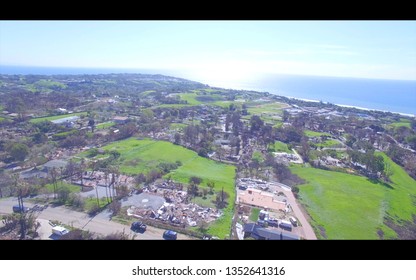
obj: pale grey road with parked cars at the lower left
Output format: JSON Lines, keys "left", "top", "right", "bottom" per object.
{"left": 0, "top": 197, "right": 191, "bottom": 240}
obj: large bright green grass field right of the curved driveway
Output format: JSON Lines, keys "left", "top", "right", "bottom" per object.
{"left": 291, "top": 154, "right": 416, "bottom": 239}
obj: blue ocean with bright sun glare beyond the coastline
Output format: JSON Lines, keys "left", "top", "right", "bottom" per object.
{"left": 0, "top": 66, "right": 416, "bottom": 115}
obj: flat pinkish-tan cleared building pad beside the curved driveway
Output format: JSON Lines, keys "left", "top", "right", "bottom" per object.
{"left": 238, "top": 188, "right": 286, "bottom": 211}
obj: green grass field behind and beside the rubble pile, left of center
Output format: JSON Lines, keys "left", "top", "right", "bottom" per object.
{"left": 83, "top": 138, "right": 235, "bottom": 238}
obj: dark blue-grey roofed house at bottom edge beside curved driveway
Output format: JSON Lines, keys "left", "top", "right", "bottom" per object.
{"left": 243, "top": 223, "right": 300, "bottom": 240}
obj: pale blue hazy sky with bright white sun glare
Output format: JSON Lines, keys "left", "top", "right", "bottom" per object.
{"left": 0, "top": 21, "right": 416, "bottom": 81}
